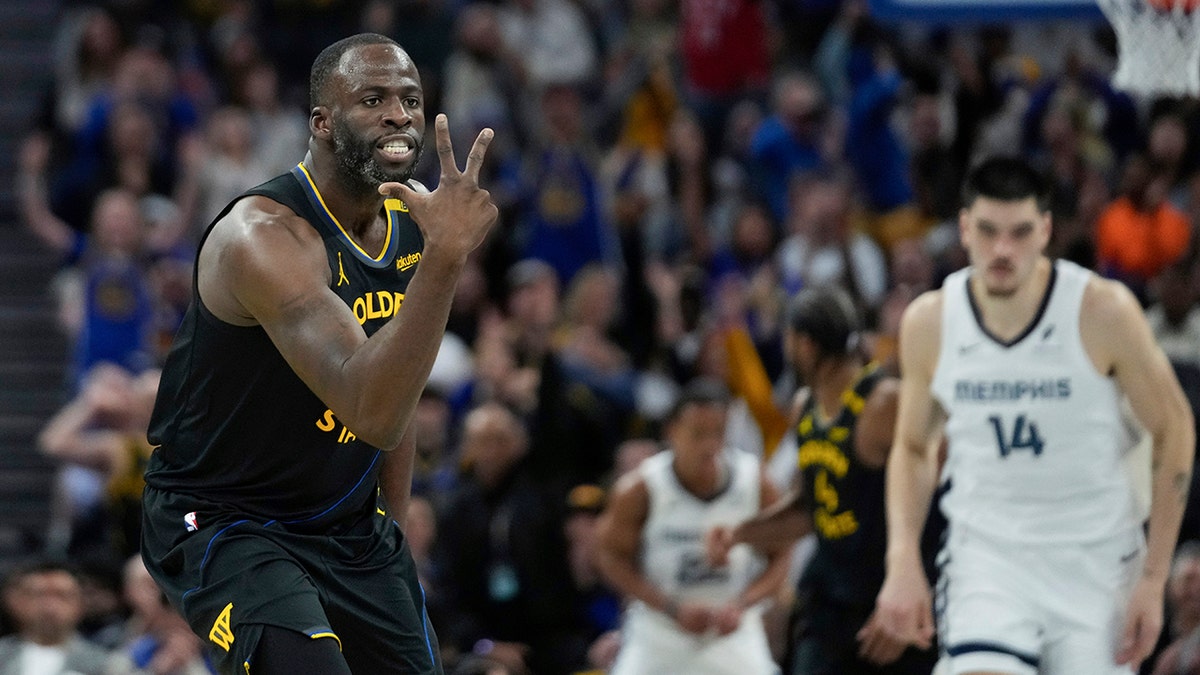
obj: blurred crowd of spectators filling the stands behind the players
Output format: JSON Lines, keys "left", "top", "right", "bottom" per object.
{"left": 7, "top": 0, "right": 1200, "bottom": 675}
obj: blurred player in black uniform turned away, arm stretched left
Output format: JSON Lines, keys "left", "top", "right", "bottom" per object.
{"left": 709, "top": 286, "right": 936, "bottom": 675}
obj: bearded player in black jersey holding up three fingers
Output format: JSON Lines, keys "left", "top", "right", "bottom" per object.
{"left": 143, "top": 35, "right": 497, "bottom": 675}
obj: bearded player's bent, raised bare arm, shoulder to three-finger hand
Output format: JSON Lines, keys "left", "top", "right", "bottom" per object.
{"left": 198, "top": 115, "right": 496, "bottom": 449}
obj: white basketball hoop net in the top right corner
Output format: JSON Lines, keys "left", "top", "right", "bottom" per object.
{"left": 1098, "top": 0, "right": 1200, "bottom": 96}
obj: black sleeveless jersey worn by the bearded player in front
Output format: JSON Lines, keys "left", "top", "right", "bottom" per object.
{"left": 145, "top": 165, "right": 424, "bottom": 527}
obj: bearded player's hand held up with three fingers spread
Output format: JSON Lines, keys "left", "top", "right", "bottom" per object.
{"left": 379, "top": 114, "right": 499, "bottom": 258}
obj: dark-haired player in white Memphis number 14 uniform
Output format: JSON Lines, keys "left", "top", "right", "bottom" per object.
{"left": 877, "top": 157, "right": 1194, "bottom": 675}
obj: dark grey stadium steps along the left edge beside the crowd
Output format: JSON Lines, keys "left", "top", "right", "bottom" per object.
{"left": 0, "top": 0, "right": 67, "bottom": 552}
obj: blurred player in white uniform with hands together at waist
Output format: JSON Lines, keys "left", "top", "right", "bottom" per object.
{"left": 599, "top": 380, "right": 787, "bottom": 675}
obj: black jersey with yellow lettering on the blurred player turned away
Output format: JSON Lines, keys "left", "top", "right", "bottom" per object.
{"left": 796, "top": 364, "right": 887, "bottom": 604}
